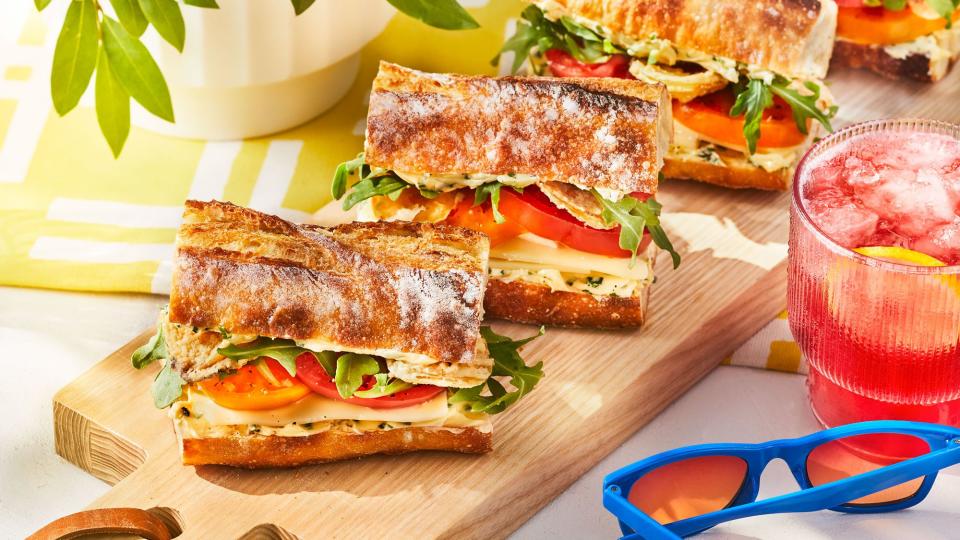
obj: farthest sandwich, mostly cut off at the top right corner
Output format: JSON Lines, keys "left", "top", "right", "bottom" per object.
{"left": 833, "top": 0, "right": 960, "bottom": 82}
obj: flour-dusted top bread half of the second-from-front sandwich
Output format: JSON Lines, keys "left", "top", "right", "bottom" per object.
{"left": 366, "top": 62, "right": 672, "bottom": 193}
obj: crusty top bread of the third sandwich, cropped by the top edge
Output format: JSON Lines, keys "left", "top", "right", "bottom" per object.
{"left": 534, "top": 0, "right": 837, "bottom": 79}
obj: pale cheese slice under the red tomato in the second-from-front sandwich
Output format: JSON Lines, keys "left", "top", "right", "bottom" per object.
{"left": 490, "top": 233, "right": 650, "bottom": 281}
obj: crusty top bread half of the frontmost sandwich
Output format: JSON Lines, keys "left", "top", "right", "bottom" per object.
{"left": 169, "top": 201, "right": 490, "bottom": 370}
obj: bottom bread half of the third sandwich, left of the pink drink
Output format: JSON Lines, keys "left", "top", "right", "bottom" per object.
{"left": 663, "top": 148, "right": 793, "bottom": 191}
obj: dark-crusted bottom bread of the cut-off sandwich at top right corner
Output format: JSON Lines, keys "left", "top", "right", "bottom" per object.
{"left": 833, "top": 31, "right": 960, "bottom": 82}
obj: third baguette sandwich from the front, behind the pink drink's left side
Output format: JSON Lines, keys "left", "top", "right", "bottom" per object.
{"left": 494, "top": 0, "right": 837, "bottom": 190}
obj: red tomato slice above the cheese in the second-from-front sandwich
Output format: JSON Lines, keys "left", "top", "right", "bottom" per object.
{"left": 500, "top": 186, "right": 650, "bottom": 257}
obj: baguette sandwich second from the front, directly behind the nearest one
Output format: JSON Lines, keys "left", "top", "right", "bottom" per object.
{"left": 332, "top": 63, "right": 679, "bottom": 327}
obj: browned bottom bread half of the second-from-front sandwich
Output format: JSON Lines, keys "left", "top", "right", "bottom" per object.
{"left": 483, "top": 279, "right": 650, "bottom": 328}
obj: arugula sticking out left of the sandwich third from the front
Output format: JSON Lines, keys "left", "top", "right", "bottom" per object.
{"left": 491, "top": 6, "right": 625, "bottom": 74}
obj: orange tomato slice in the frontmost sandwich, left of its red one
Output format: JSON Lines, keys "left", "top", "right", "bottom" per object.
{"left": 198, "top": 358, "right": 310, "bottom": 411}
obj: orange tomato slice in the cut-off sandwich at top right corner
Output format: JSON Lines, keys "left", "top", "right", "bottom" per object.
{"left": 837, "top": 4, "right": 960, "bottom": 45}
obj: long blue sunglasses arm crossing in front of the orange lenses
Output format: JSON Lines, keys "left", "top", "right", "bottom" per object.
{"left": 670, "top": 442, "right": 960, "bottom": 536}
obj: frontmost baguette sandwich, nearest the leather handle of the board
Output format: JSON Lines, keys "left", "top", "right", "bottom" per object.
{"left": 132, "top": 201, "right": 542, "bottom": 468}
